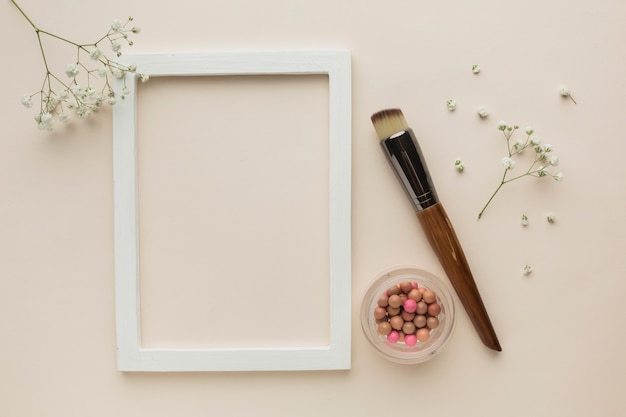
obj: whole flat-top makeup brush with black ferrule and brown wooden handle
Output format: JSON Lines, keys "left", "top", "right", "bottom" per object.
{"left": 372, "top": 109, "right": 502, "bottom": 351}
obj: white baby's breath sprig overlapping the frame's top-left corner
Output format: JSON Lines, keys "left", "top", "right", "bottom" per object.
{"left": 10, "top": 0, "right": 148, "bottom": 130}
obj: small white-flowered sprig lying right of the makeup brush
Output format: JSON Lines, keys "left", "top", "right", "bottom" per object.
{"left": 478, "top": 121, "right": 563, "bottom": 219}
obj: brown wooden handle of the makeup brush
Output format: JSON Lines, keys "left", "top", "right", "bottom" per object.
{"left": 417, "top": 203, "right": 502, "bottom": 351}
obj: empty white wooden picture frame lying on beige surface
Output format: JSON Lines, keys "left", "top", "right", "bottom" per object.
{"left": 113, "top": 50, "right": 352, "bottom": 372}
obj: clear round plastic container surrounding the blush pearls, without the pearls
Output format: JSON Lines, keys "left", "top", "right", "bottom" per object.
{"left": 361, "top": 265, "right": 455, "bottom": 364}
